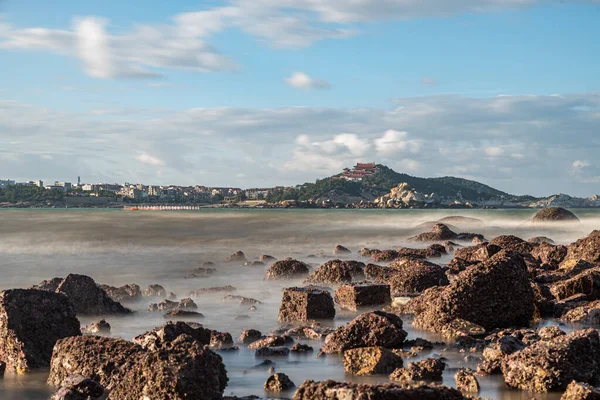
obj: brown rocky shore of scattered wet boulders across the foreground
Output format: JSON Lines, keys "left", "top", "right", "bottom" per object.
{"left": 0, "top": 208, "right": 600, "bottom": 400}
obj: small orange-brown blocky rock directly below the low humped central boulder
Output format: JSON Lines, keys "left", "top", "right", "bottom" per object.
{"left": 343, "top": 347, "right": 403, "bottom": 375}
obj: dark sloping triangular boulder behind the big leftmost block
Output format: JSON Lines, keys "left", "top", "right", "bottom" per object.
{"left": 56, "top": 274, "right": 131, "bottom": 315}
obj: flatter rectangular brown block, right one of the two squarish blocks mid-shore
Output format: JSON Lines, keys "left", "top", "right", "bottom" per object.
{"left": 334, "top": 282, "right": 392, "bottom": 311}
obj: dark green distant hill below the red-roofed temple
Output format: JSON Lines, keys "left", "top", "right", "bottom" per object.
{"left": 267, "top": 165, "right": 516, "bottom": 203}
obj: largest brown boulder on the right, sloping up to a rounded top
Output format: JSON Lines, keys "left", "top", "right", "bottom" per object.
{"left": 413, "top": 251, "right": 534, "bottom": 332}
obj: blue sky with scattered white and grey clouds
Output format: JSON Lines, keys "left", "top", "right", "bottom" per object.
{"left": 0, "top": 0, "right": 600, "bottom": 196}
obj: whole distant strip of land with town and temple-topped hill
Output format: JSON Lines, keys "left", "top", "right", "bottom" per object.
{"left": 0, "top": 163, "right": 600, "bottom": 209}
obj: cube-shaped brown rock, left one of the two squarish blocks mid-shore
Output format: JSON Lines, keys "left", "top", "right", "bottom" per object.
{"left": 277, "top": 287, "right": 335, "bottom": 322}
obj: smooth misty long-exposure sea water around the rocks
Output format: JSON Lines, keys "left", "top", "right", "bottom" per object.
{"left": 0, "top": 209, "right": 600, "bottom": 400}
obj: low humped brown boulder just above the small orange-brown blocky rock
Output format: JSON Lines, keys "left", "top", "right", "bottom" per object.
{"left": 321, "top": 311, "right": 407, "bottom": 354}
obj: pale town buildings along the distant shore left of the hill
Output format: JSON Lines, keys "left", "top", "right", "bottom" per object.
{"left": 0, "top": 178, "right": 284, "bottom": 203}
